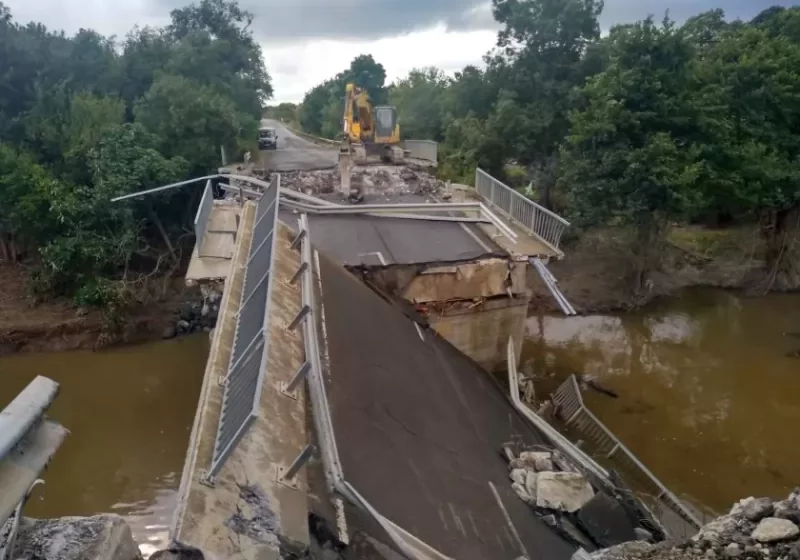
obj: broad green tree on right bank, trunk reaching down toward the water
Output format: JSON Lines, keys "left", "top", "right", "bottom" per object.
{"left": 561, "top": 19, "right": 701, "bottom": 294}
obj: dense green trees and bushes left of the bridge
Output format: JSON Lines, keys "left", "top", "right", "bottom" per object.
{"left": 0, "top": 0, "right": 272, "bottom": 307}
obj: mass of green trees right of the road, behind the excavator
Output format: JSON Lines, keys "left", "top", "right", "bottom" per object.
{"left": 299, "top": 0, "right": 800, "bottom": 291}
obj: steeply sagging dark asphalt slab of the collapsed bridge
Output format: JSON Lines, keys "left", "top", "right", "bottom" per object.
{"left": 312, "top": 254, "right": 574, "bottom": 560}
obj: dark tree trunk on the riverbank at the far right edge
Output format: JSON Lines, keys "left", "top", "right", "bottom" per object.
{"left": 759, "top": 205, "right": 800, "bottom": 293}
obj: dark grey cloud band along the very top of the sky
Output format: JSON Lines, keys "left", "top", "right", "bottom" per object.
{"left": 2, "top": 0, "right": 793, "bottom": 48}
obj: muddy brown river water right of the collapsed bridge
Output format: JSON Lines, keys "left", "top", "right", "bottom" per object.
{"left": 521, "top": 289, "right": 800, "bottom": 511}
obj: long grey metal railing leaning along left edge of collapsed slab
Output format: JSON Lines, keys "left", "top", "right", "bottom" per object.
{"left": 205, "top": 175, "right": 280, "bottom": 483}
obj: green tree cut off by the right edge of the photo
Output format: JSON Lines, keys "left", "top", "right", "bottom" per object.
{"left": 696, "top": 27, "right": 800, "bottom": 288}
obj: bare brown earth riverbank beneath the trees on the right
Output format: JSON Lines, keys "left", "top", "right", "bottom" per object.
{"left": 529, "top": 227, "right": 780, "bottom": 314}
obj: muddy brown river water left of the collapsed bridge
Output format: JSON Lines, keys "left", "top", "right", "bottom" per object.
{"left": 0, "top": 334, "right": 209, "bottom": 555}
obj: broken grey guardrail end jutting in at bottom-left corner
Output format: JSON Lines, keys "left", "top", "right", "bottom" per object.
{"left": 0, "top": 376, "right": 67, "bottom": 560}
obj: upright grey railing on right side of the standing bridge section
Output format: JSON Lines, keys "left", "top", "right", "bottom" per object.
{"left": 475, "top": 168, "right": 569, "bottom": 253}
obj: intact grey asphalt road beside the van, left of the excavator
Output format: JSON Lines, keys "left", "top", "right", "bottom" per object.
{"left": 259, "top": 119, "right": 338, "bottom": 171}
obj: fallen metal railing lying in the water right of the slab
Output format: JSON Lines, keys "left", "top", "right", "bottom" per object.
{"left": 552, "top": 375, "right": 703, "bottom": 538}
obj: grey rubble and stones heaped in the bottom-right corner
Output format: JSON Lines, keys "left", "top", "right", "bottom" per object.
{"left": 590, "top": 488, "right": 800, "bottom": 560}
